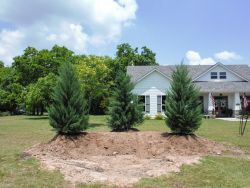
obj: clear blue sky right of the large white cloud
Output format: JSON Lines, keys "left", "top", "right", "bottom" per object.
{"left": 121, "top": 0, "right": 250, "bottom": 64}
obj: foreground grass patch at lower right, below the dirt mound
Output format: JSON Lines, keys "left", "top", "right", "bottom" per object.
{"left": 135, "top": 157, "right": 250, "bottom": 188}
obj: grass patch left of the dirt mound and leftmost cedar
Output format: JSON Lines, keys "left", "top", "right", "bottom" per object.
{"left": 0, "top": 116, "right": 67, "bottom": 188}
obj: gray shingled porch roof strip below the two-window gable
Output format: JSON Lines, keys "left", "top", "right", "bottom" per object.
{"left": 195, "top": 82, "right": 250, "bottom": 93}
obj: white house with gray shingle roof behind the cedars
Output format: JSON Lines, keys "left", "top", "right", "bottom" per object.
{"left": 127, "top": 63, "right": 250, "bottom": 117}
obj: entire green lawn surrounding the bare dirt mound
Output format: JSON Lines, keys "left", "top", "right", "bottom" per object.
{"left": 0, "top": 116, "right": 250, "bottom": 188}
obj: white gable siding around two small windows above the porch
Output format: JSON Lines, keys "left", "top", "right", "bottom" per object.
{"left": 196, "top": 65, "right": 243, "bottom": 81}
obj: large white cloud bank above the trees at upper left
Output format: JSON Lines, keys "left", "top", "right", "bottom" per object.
{"left": 0, "top": 0, "right": 137, "bottom": 64}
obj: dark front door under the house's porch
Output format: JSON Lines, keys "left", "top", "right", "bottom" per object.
{"left": 214, "top": 96, "right": 228, "bottom": 117}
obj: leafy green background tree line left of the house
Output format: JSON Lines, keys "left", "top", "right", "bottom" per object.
{"left": 0, "top": 43, "right": 157, "bottom": 115}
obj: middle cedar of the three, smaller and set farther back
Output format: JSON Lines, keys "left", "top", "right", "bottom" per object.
{"left": 108, "top": 72, "right": 143, "bottom": 131}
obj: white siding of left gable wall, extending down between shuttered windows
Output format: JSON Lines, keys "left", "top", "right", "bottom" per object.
{"left": 133, "top": 71, "right": 170, "bottom": 116}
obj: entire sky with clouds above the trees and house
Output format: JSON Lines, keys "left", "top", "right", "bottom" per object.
{"left": 0, "top": 0, "right": 250, "bottom": 66}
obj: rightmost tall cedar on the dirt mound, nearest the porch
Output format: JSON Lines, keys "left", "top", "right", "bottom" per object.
{"left": 165, "top": 64, "right": 202, "bottom": 134}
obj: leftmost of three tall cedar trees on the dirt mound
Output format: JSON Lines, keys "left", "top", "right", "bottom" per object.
{"left": 49, "top": 63, "right": 88, "bottom": 134}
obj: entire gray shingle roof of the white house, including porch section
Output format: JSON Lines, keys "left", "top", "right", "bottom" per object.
{"left": 127, "top": 65, "right": 250, "bottom": 92}
